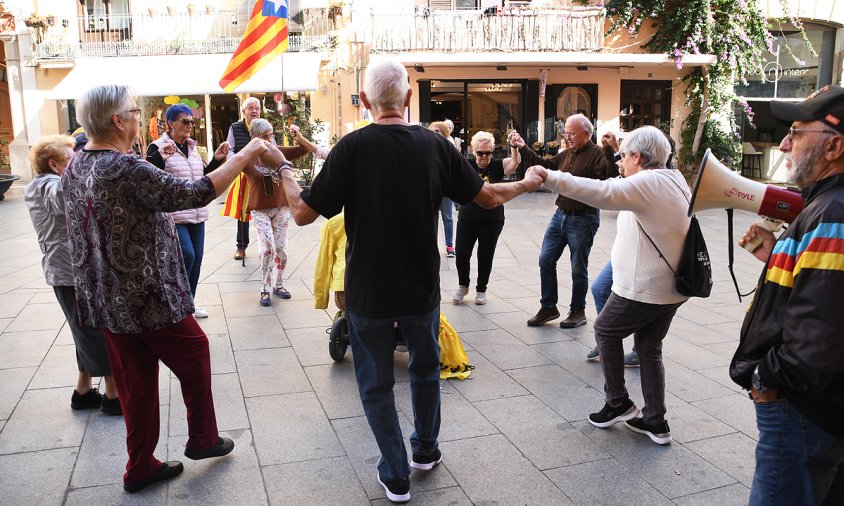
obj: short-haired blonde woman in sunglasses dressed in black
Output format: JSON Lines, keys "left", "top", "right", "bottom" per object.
{"left": 454, "top": 131, "right": 522, "bottom": 305}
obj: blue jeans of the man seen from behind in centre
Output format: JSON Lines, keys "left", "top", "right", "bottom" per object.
{"left": 346, "top": 306, "right": 440, "bottom": 480}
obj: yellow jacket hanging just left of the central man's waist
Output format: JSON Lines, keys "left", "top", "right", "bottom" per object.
{"left": 314, "top": 213, "right": 346, "bottom": 309}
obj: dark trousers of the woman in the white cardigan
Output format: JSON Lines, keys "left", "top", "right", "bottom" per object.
{"left": 595, "top": 293, "right": 683, "bottom": 424}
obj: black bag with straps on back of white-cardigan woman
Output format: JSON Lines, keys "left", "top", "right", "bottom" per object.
{"left": 636, "top": 176, "right": 712, "bottom": 298}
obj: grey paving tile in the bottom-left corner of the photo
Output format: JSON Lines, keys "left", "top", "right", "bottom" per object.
{"left": 0, "top": 448, "right": 77, "bottom": 505}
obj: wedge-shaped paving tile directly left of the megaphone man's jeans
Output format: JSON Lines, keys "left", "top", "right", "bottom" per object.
{"left": 685, "top": 432, "right": 756, "bottom": 487}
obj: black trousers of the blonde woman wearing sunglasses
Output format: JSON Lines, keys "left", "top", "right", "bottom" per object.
{"left": 455, "top": 220, "right": 504, "bottom": 292}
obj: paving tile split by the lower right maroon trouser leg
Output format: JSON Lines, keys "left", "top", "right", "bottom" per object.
{"left": 168, "top": 374, "right": 249, "bottom": 438}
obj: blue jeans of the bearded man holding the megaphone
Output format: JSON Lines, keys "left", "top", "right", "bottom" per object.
{"left": 749, "top": 398, "right": 844, "bottom": 506}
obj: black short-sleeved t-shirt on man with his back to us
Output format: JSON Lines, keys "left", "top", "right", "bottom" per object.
{"left": 302, "top": 124, "right": 483, "bottom": 318}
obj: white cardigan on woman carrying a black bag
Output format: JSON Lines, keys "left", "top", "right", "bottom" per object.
{"left": 544, "top": 169, "right": 691, "bottom": 304}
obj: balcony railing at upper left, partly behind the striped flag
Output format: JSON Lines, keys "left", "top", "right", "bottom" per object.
{"left": 32, "top": 9, "right": 329, "bottom": 60}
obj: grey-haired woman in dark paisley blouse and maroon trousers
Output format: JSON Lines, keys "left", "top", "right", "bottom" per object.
{"left": 62, "top": 85, "right": 271, "bottom": 492}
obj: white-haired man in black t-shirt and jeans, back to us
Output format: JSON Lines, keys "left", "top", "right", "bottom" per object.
{"left": 264, "top": 59, "right": 541, "bottom": 502}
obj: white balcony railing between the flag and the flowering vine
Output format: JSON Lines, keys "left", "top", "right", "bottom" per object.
{"left": 371, "top": 7, "right": 605, "bottom": 53}
